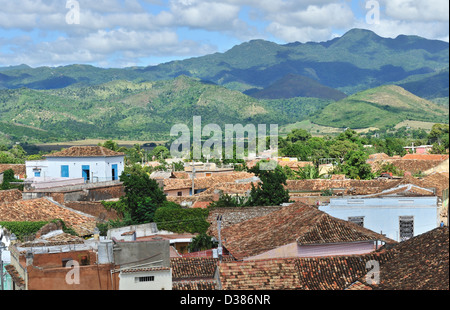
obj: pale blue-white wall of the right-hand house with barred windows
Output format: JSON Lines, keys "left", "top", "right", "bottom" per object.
{"left": 319, "top": 197, "right": 439, "bottom": 241}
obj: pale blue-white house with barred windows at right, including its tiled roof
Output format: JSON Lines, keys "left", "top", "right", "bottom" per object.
{"left": 319, "top": 184, "right": 439, "bottom": 242}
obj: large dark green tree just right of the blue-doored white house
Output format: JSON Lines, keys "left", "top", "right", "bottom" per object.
{"left": 120, "top": 165, "right": 167, "bottom": 224}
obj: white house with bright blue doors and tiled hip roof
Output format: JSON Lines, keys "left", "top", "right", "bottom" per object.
{"left": 26, "top": 146, "right": 125, "bottom": 183}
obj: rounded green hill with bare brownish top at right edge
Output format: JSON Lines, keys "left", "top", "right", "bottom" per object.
{"left": 311, "top": 85, "right": 449, "bottom": 129}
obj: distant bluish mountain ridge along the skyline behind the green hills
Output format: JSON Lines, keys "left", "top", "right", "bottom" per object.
{"left": 0, "top": 29, "right": 449, "bottom": 94}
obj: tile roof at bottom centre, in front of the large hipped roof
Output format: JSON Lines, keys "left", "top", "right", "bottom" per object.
{"left": 218, "top": 251, "right": 390, "bottom": 290}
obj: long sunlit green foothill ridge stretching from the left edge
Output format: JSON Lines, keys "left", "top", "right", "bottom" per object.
{"left": 0, "top": 76, "right": 329, "bottom": 143}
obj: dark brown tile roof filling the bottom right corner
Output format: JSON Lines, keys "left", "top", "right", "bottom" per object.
{"left": 375, "top": 227, "right": 449, "bottom": 290}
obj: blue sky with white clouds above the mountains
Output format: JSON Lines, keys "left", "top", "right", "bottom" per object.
{"left": 0, "top": 0, "right": 449, "bottom": 68}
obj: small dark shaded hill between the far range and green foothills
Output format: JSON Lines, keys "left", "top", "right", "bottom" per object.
{"left": 244, "top": 74, "right": 347, "bottom": 101}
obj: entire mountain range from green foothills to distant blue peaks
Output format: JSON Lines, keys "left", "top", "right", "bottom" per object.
{"left": 0, "top": 29, "right": 449, "bottom": 143}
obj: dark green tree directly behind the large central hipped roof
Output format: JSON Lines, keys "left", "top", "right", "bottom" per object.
{"left": 247, "top": 161, "right": 290, "bottom": 206}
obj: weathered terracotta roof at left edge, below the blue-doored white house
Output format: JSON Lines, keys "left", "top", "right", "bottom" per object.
{"left": 0, "top": 198, "right": 96, "bottom": 236}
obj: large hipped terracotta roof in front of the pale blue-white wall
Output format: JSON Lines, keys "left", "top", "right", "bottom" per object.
{"left": 222, "top": 203, "right": 395, "bottom": 259}
